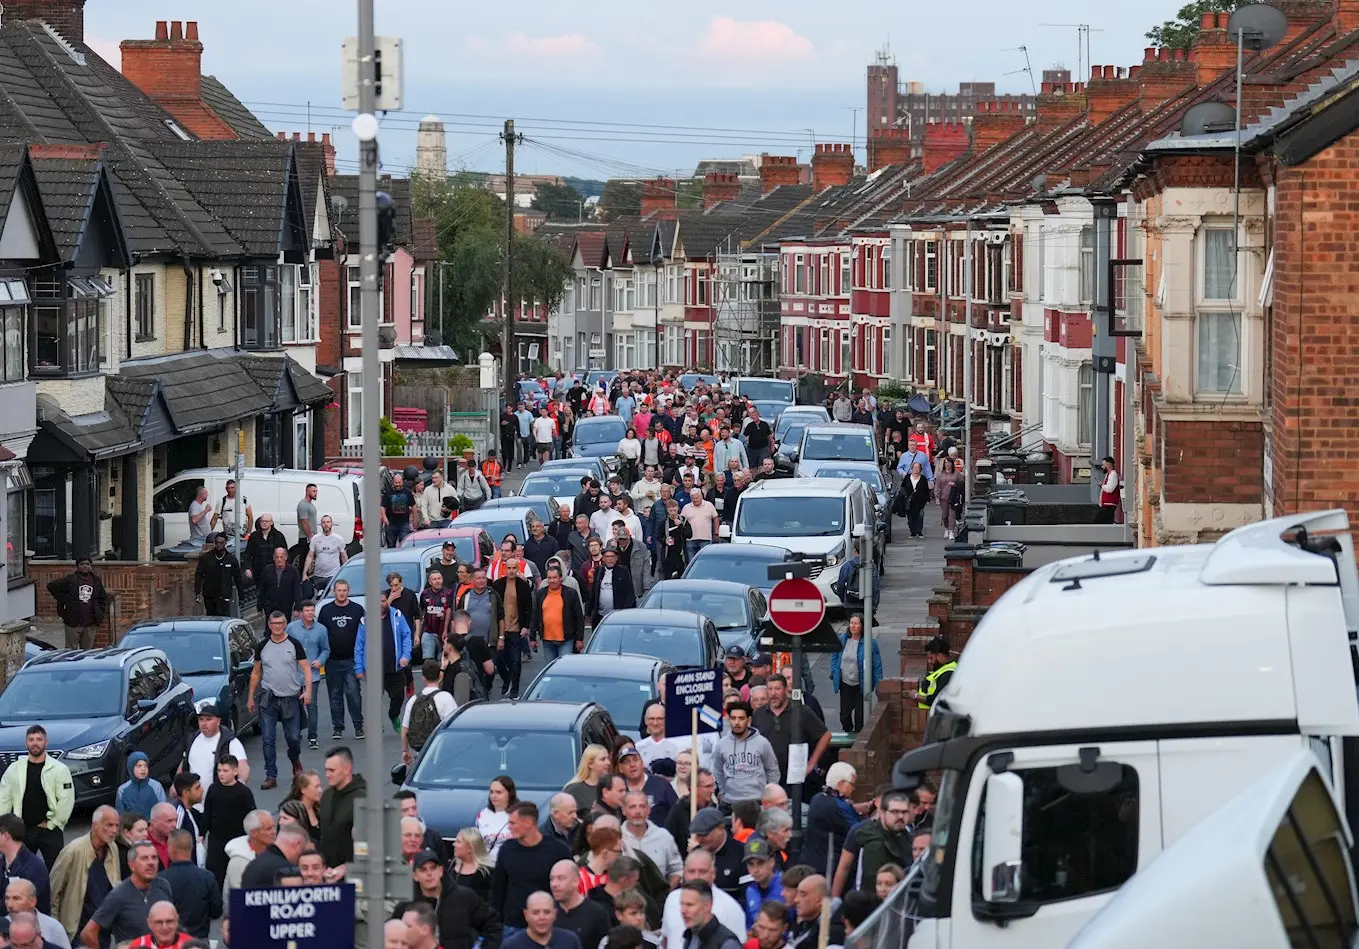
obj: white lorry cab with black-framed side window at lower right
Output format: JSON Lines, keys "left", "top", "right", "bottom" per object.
{"left": 894, "top": 511, "right": 1359, "bottom": 949}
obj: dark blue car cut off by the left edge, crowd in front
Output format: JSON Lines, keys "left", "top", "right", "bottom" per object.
{"left": 0, "top": 646, "right": 197, "bottom": 808}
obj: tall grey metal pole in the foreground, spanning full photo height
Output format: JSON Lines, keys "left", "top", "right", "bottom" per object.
{"left": 355, "top": 0, "right": 387, "bottom": 948}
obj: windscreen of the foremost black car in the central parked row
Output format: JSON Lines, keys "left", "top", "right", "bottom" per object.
{"left": 410, "top": 726, "right": 576, "bottom": 790}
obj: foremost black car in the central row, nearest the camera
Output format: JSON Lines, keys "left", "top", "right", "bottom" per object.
{"left": 391, "top": 702, "right": 618, "bottom": 842}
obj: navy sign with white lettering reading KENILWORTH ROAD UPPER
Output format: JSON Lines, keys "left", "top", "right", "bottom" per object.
{"left": 231, "top": 884, "right": 355, "bottom": 949}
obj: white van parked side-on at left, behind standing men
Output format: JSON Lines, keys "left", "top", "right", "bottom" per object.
{"left": 151, "top": 468, "right": 363, "bottom": 549}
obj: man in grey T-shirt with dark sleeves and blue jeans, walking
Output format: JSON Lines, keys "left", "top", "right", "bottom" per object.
{"left": 249, "top": 610, "right": 311, "bottom": 791}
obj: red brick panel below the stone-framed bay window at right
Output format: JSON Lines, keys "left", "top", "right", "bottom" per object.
{"left": 1162, "top": 419, "right": 1264, "bottom": 504}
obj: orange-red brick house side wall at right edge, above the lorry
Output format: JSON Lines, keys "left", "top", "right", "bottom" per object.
{"left": 1267, "top": 128, "right": 1359, "bottom": 518}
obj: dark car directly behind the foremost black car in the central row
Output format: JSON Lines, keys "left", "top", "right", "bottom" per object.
{"left": 523, "top": 654, "right": 675, "bottom": 738}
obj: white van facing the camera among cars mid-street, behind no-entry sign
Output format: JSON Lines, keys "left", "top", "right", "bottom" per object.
{"left": 723, "top": 477, "right": 874, "bottom": 608}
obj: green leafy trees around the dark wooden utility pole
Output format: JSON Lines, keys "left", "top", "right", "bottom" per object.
{"left": 419, "top": 174, "right": 572, "bottom": 351}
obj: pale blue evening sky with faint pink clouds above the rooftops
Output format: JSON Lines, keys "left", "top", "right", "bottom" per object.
{"left": 86, "top": 0, "right": 1182, "bottom": 178}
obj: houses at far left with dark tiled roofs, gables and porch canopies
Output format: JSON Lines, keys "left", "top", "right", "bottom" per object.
{"left": 0, "top": 0, "right": 332, "bottom": 620}
